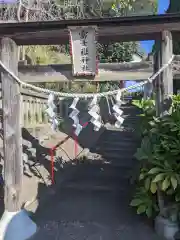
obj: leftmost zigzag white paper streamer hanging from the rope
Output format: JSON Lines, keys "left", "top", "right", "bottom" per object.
{"left": 46, "top": 93, "right": 58, "bottom": 130}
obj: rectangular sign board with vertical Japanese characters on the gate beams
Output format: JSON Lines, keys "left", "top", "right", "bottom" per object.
{"left": 69, "top": 26, "right": 97, "bottom": 76}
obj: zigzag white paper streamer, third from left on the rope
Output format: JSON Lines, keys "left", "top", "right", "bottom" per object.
{"left": 88, "top": 96, "right": 102, "bottom": 131}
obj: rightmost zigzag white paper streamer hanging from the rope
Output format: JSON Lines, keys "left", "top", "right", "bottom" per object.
{"left": 113, "top": 91, "right": 124, "bottom": 128}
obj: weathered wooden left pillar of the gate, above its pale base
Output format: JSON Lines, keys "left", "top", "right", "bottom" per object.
{"left": 0, "top": 38, "right": 23, "bottom": 211}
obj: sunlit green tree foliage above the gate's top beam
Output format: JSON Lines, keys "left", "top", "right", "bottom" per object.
{"left": 54, "top": 0, "right": 157, "bottom": 19}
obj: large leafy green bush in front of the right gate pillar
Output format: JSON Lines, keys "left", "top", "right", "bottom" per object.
{"left": 131, "top": 95, "right": 180, "bottom": 218}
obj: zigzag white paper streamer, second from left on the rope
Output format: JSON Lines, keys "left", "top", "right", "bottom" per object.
{"left": 69, "top": 98, "right": 82, "bottom": 136}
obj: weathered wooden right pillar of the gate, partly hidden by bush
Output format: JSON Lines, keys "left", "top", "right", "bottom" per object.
{"left": 154, "top": 31, "right": 173, "bottom": 237}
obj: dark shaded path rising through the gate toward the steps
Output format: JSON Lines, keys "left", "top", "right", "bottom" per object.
{"left": 30, "top": 105, "right": 161, "bottom": 240}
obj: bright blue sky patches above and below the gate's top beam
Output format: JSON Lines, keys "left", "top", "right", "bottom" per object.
{"left": 141, "top": 0, "right": 170, "bottom": 53}
